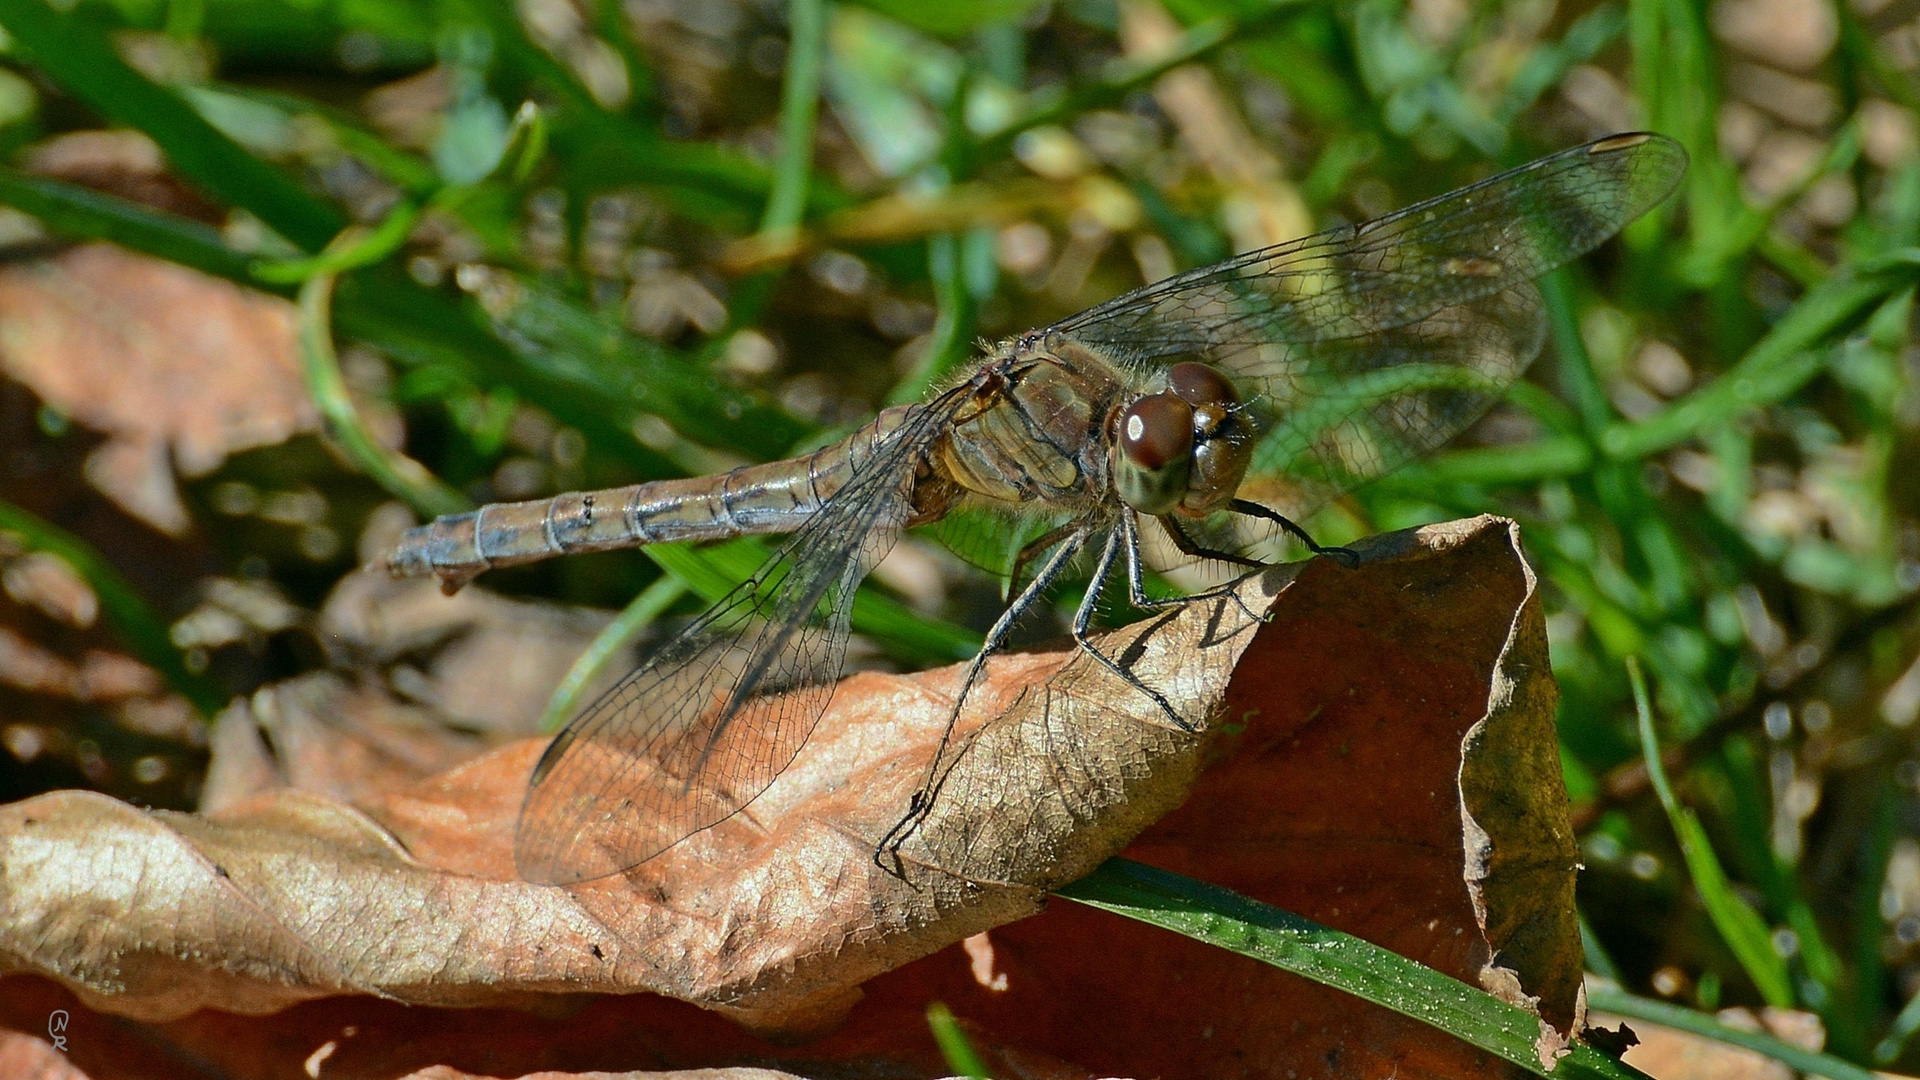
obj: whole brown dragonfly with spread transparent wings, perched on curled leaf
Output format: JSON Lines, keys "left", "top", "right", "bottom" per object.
{"left": 388, "top": 133, "right": 1686, "bottom": 884}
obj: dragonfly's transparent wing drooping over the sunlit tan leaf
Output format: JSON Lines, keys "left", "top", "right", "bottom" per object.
{"left": 513, "top": 394, "right": 960, "bottom": 884}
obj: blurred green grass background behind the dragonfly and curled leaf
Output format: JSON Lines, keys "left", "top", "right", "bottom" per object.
{"left": 0, "top": 0, "right": 1920, "bottom": 1072}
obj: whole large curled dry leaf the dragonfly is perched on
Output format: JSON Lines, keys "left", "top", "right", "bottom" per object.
{"left": 0, "top": 519, "right": 1582, "bottom": 1078}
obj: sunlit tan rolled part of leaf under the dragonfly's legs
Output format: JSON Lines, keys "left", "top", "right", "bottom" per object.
{"left": 0, "top": 557, "right": 1244, "bottom": 1028}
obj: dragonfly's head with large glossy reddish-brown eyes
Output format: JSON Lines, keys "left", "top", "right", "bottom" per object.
{"left": 1112, "top": 363, "right": 1254, "bottom": 517}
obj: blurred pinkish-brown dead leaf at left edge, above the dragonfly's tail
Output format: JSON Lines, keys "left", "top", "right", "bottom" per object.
{"left": 0, "top": 244, "right": 319, "bottom": 536}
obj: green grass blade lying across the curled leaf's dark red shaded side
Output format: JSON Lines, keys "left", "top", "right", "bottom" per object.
{"left": 1056, "top": 859, "right": 1644, "bottom": 1080}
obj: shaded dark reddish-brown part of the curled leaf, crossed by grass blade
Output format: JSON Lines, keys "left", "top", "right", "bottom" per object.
{"left": 868, "top": 507, "right": 1584, "bottom": 1080}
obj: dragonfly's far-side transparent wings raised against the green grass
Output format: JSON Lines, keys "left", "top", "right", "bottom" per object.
{"left": 1048, "top": 133, "right": 1686, "bottom": 507}
